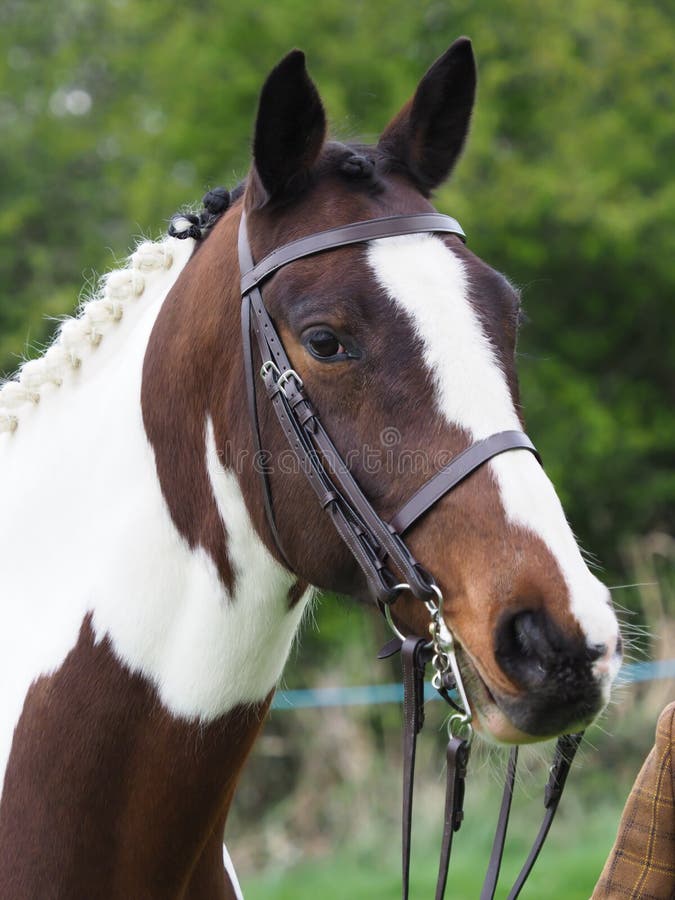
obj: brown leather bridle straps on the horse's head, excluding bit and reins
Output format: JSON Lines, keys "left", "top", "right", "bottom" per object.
{"left": 239, "top": 213, "right": 537, "bottom": 607}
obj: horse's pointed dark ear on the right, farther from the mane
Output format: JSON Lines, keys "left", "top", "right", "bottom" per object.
{"left": 379, "top": 38, "right": 476, "bottom": 195}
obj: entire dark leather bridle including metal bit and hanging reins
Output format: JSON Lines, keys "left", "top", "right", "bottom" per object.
{"left": 239, "top": 211, "right": 581, "bottom": 900}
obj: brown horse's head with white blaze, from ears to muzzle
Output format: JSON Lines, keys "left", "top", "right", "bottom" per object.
{"left": 146, "top": 39, "right": 621, "bottom": 742}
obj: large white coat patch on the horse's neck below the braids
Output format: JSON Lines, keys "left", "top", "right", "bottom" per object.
{"left": 0, "top": 242, "right": 309, "bottom": 796}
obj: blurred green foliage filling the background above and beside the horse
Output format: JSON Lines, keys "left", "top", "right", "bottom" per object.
{"left": 0, "top": 0, "right": 675, "bottom": 570}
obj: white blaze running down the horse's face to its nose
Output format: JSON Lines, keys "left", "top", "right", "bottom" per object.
{"left": 368, "top": 235, "right": 618, "bottom": 666}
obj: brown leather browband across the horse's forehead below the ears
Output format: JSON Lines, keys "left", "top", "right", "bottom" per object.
{"left": 241, "top": 213, "right": 466, "bottom": 294}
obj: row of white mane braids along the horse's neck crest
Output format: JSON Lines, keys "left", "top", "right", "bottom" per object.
{"left": 0, "top": 238, "right": 182, "bottom": 433}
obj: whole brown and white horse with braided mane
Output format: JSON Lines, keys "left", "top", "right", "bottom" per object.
{"left": 0, "top": 38, "right": 621, "bottom": 900}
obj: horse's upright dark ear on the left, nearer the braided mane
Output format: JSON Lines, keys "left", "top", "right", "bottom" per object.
{"left": 251, "top": 50, "right": 326, "bottom": 206}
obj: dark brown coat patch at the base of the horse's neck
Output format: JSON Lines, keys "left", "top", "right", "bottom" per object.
{"left": 0, "top": 619, "right": 269, "bottom": 900}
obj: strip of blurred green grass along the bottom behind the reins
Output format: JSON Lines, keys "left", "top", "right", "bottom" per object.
{"left": 242, "top": 760, "right": 622, "bottom": 900}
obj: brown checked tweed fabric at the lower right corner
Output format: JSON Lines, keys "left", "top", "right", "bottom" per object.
{"left": 592, "top": 702, "right": 675, "bottom": 900}
